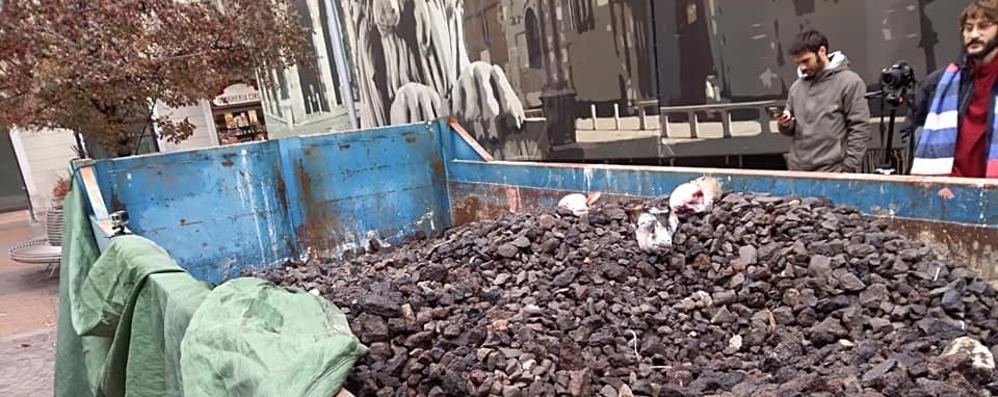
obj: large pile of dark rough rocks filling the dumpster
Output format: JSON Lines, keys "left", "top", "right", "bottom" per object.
{"left": 257, "top": 194, "right": 998, "bottom": 397}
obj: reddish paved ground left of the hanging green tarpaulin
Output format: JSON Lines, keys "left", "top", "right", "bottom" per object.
{"left": 0, "top": 211, "right": 59, "bottom": 396}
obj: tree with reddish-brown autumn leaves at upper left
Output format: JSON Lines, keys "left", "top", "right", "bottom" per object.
{"left": 0, "top": 0, "right": 311, "bottom": 156}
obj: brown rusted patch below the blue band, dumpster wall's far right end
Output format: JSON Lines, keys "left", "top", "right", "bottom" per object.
{"left": 887, "top": 218, "right": 998, "bottom": 282}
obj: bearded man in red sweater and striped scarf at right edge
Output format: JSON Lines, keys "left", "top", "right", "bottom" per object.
{"left": 902, "top": 0, "right": 998, "bottom": 178}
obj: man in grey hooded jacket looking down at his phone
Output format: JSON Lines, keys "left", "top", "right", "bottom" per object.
{"left": 777, "top": 30, "right": 870, "bottom": 172}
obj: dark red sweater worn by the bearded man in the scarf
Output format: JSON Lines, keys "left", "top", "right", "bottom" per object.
{"left": 952, "top": 56, "right": 998, "bottom": 178}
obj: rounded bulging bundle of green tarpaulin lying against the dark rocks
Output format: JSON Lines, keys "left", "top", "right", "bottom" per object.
{"left": 181, "top": 278, "right": 366, "bottom": 397}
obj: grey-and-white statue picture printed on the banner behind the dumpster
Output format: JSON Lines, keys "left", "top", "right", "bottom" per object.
{"left": 342, "top": 0, "right": 540, "bottom": 158}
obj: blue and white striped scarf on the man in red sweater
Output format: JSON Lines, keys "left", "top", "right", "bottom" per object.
{"left": 911, "top": 63, "right": 998, "bottom": 178}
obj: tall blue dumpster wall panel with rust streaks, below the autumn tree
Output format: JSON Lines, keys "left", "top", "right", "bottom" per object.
{"left": 94, "top": 123, "right": 449, "bottom": 283}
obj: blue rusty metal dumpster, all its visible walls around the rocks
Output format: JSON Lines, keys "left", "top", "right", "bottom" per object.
{"left": 76, "top": 120, "right": 998, "bottom": 283}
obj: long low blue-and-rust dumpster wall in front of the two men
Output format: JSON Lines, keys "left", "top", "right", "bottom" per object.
{"left": 448, "top": 159, "right": 998, "bottom": 280}
